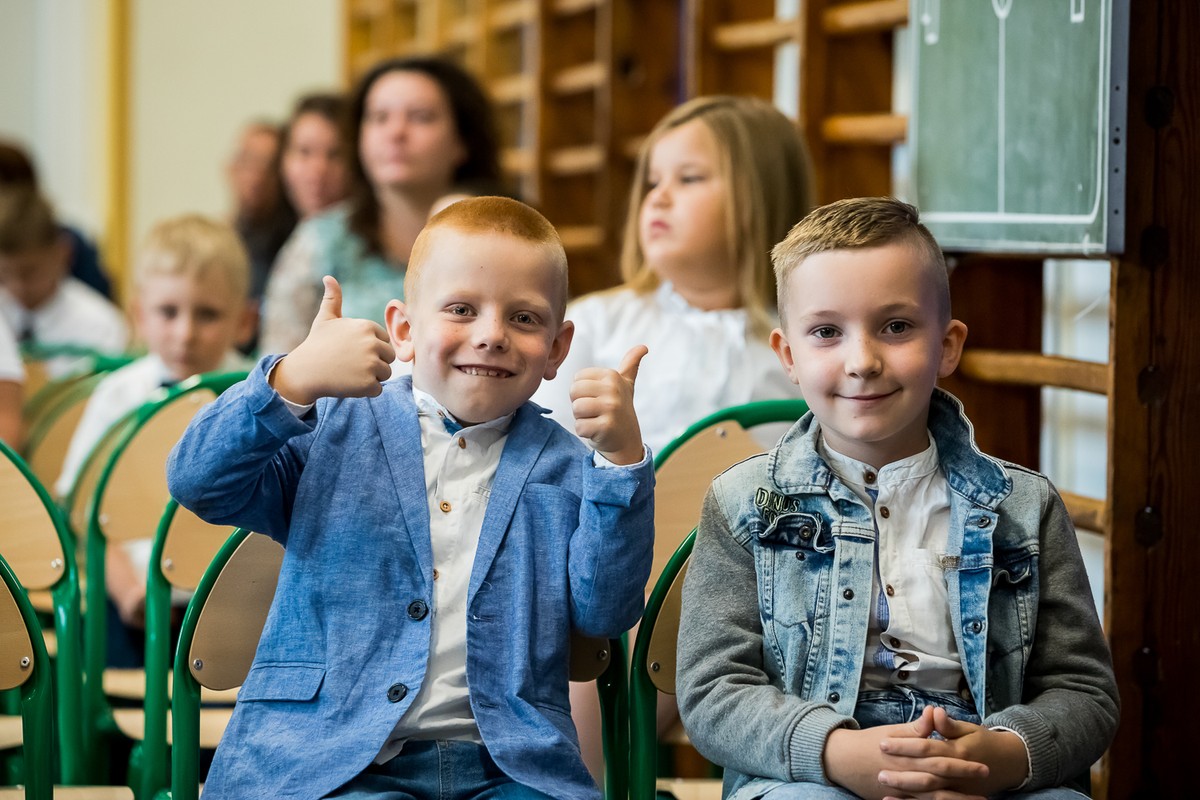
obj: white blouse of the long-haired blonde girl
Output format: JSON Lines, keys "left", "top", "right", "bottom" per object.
{"left": 533, "top": 283, "right": 800, "bottom": 452}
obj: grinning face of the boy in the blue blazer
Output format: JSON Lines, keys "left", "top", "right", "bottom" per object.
{"left": 386, "top": 227, "right": 574, "bottom": 425}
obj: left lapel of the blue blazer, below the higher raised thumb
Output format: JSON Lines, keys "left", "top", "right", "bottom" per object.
{"left": 370, "top": 375, "right": 433, "bottom": 585}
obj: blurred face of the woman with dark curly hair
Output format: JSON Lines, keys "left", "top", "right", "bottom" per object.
{"left": 359, "top": 70, "right": 467, "bottom": 196}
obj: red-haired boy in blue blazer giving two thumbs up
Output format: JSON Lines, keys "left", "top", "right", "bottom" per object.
{"left": 167, "top": 197, "right": 654, "bottom": 800}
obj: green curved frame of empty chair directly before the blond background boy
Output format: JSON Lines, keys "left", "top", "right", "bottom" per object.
{"left": 72, "top": 372, "right": 246, "bottom": 782}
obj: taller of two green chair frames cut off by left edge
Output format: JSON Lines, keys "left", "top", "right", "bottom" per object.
{"left": 0, "top": 441, "right": 91, "bottom": 786}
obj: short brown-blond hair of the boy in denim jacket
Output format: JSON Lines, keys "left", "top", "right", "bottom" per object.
{"left": 770, "top": 197, "right": 950, "bottom": 323}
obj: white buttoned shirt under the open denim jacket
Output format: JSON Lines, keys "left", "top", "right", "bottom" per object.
{"left": 820, "top": 438, "right": 965, "bottom": 692}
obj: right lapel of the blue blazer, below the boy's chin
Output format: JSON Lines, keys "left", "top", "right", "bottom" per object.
{"left": 467, "top": 403, "right": 552, "bottom": 606}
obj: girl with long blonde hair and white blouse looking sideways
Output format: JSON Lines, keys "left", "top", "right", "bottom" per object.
{"left": 534, "top": 96, "right": 811, "bottom": 451}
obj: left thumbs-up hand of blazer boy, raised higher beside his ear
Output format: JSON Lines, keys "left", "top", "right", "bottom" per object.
{"left": 271, "top": 275, "right": 396, "bottom": 405}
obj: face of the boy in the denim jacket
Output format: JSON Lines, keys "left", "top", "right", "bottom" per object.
{"left": 770, "top": 242, "right": 966, "bottom": 468}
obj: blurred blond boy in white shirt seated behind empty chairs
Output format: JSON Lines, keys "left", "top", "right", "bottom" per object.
{"left": 55, "top": 215, "right": 254, "bottom": 667}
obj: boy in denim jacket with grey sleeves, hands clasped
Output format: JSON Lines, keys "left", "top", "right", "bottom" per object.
{"left": 678, "top": 198, "right": 1117, "bottom": 800}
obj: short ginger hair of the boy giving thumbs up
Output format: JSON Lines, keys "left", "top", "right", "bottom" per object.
{"left": 404, "top": 197, "right": 568, "bottom": 321}
